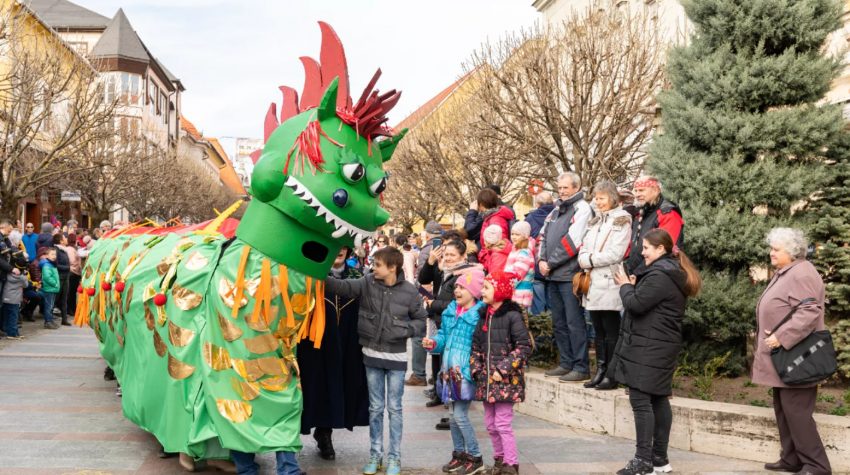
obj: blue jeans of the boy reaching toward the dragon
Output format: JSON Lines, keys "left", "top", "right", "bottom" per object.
{"left": 366, "top": 366, "right": 405, "bottom": 461}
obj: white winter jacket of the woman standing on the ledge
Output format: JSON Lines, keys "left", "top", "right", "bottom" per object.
{"left": 578, "top": 208, "right": 632, "bottom": 311}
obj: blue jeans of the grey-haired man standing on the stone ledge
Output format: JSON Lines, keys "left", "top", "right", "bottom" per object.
{"left": 546, "top": 281, "right": 590, "bottom": 373}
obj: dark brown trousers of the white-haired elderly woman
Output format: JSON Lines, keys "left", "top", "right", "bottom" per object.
{"left": 773, "top": 387, "right": 832, "bottom": 475}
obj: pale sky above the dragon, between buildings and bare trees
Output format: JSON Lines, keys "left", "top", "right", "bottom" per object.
{"left": 72, "top": 0, "right": 538, "bottom": 138}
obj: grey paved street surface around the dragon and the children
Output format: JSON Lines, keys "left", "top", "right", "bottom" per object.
{"left": 0, "top": 322, "right": 762, "bottom": 475}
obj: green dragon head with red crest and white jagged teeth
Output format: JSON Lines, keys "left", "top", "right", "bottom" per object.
{"left": 232, "top": 22, "right": 406, "bottom": 277}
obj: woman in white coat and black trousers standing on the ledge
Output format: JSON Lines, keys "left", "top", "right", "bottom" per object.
{"left": 578, "top": 180, "right": 632, "bottom": 389}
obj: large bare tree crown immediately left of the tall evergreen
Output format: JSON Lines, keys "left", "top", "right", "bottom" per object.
{"left": 467, "top": 5, "right": 665, "bottom": 189}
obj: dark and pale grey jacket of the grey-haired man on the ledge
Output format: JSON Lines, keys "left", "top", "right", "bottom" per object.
{"left": 537, "top": 192, "right": 593, "bottom": 282}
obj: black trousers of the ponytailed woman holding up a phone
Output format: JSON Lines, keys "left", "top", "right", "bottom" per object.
{"left": 629, "top": 388, "right": 673, "bottom": 462}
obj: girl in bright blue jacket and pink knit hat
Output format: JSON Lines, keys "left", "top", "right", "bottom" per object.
{"left": 422, "top": 267, "right": 485, "bottom": 475}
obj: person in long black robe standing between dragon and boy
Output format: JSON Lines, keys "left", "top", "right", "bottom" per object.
{"left": 297, "top": 248, "right": 369, "bottom": 460}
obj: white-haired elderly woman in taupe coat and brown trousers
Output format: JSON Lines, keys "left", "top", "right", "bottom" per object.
{"left": 753, "top": 228, "right": 832, "bottom": 475}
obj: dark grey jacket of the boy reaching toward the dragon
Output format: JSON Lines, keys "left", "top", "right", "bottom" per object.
{"left": 325, "top": 274, "right": 427, "bottom": 370}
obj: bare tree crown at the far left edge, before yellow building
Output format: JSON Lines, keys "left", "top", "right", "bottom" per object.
{"left": 0, "top": 2, "right": 114, "bottom": 216}
